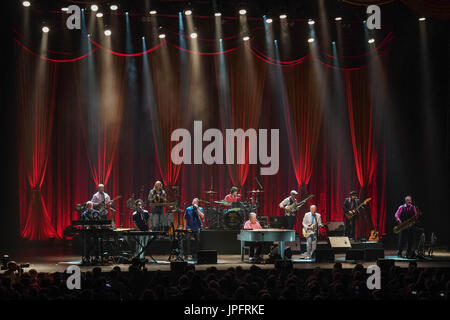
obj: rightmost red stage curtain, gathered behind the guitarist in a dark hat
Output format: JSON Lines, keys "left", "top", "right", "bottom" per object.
{"left": 344, "top": 68, "right": 384, "bottom": 238}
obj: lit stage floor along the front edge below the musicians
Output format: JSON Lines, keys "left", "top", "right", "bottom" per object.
{"left": 0, "top": 244, "right": 450, "bottom": 274}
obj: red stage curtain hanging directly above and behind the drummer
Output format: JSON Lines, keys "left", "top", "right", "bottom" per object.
{"left": 221, "top": 48, "right": 267, "bottom": 187}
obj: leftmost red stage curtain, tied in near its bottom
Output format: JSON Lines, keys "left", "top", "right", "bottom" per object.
{"left": 17, "top": 54, "right": 57, "bottom": 240}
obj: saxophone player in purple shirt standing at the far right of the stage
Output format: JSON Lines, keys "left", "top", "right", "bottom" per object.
{"left": 395, "top": 196, "right": 419, "bottom": 259}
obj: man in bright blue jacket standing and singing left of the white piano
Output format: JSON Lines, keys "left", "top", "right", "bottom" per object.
{"left": 184, "top": 198, "right": 205, "bottom": 260}
